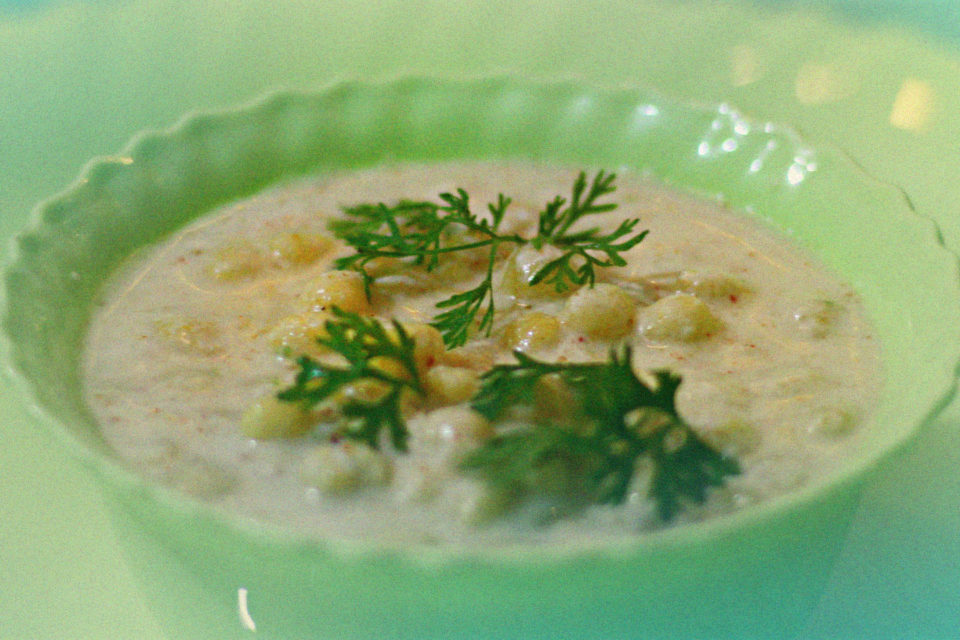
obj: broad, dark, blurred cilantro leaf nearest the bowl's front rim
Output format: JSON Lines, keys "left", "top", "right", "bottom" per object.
{"left": 461, "top": 347, "right": 740, "bottom": 521}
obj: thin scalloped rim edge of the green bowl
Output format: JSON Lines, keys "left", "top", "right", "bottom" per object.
{"left": 0, "top": 76, "right": 960, "bottom": 565}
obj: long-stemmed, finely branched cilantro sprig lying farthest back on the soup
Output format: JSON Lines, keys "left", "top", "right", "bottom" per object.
{"left": 330, "top": 170, "right": 647, "bottom": 348}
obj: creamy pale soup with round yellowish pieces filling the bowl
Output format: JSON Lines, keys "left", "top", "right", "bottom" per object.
{"left": 84, "top": 163, "right": 880, "bottom": 545}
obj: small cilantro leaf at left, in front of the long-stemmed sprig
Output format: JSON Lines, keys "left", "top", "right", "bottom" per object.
{"left": 277, "top": 307, "right": 423, "bottom": 451}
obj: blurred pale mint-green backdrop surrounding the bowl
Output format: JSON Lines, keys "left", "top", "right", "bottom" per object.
{"left": 0, "top": 0, "right": 960, "bottom": 639}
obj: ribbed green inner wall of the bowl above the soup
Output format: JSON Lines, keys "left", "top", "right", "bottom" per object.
{"left": 3, "top": 78, "right": 960, "bottom": 552}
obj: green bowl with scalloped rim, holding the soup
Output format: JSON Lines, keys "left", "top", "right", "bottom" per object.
{"left": 0, "top": 78, "right": 960, "bottom": 638}
